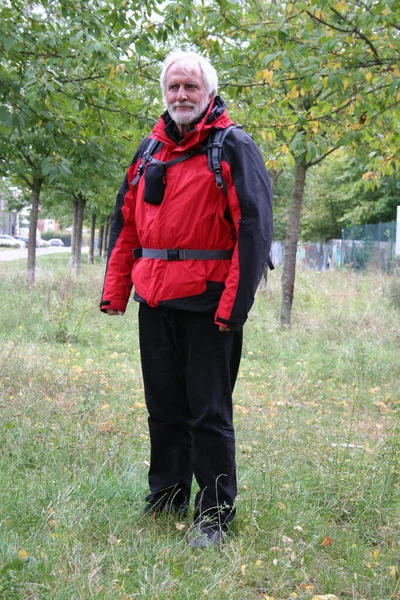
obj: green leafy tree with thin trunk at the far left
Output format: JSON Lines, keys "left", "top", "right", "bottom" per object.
{"left": 0, "top": 0, "right": 164, "bottom": 284}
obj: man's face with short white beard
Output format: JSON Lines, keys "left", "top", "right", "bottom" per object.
{"left": 165, "top": 64, "right": 211, "bottom": 133}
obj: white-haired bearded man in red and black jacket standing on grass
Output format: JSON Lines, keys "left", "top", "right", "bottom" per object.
{"left": 101, "top": 51, "right": 272, "bottom": 547}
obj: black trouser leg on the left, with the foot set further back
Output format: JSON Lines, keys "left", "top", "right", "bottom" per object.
{"left": 139, "top": 304, "right": 192, "bottom": 508}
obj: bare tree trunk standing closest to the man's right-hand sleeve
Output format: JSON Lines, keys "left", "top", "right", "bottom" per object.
{"left": 281, "top": 158, "right": 307, "bottom": 326}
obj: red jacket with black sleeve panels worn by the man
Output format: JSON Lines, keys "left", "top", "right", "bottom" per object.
{"left": 100, "top": 96, "right": 272, "bottom": 329}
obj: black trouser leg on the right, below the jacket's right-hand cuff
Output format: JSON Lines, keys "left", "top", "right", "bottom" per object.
{"left": 180, "top": 312, "right": 242, "bottom": 523}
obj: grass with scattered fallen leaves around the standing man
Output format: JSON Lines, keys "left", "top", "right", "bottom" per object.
{"left": 0, "top": 254, "right": 400, "bottom": 600}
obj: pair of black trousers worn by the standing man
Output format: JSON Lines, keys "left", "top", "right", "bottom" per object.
{"left": 139, "top": 304, "right": 242, "bottom": 523}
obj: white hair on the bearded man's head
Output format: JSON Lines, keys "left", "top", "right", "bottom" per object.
{"left": 160, "top": 50, "right": 218, "bottom": 103}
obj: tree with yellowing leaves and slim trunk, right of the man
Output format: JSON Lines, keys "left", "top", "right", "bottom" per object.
{"left": 170, "top": 0, "right": 400, "bottom": 325}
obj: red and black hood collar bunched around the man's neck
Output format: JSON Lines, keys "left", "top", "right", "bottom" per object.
{"left": 151, "top": 96, "right": 233, "bottom": 150}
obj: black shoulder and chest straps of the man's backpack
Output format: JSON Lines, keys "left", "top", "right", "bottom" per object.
{"left": 132, "top": 125, "right": 241, "bottom": 196}
